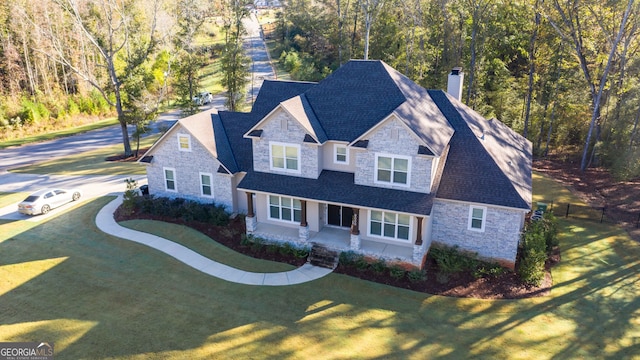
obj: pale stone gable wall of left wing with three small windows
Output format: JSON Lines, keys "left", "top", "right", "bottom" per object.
{"left": 147, "top": 126, "right": 236, "bottom": 212}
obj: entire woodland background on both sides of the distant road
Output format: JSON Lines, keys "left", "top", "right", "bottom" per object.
{"left": 0, "top": 0, "right": 640, "bottom": 179}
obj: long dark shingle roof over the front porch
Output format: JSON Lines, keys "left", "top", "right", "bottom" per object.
{"left": 238, "top": 170, "right": 435, "bottom": 215}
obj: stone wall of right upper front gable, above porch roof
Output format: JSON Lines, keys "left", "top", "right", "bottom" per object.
{"left": 351, "top": 118, "right": 433, "bottom": 193}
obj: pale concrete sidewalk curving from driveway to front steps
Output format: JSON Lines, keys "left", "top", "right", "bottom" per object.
{"left": 96, "top": 195, "right": 332, "bottom": 286}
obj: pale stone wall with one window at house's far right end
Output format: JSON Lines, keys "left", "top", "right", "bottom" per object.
{"left": 431, "top": 200, "right": 525, "bottom": 268}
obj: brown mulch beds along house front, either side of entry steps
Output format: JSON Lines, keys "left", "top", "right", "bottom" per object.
{"left": 114, "top": 204, "right": 560, "bottom": 299}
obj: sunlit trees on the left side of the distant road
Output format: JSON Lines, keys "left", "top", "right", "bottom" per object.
{"left": 0, "top": 0, "right": 247, "bottom": 156}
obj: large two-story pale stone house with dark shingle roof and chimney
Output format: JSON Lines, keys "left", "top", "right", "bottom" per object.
{"left": 144, "top": 60, "right": 531, "bottom": 268}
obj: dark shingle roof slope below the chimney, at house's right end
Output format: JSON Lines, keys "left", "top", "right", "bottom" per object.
{"left": 429, "top": 90, "right": 531, "bottom": 209}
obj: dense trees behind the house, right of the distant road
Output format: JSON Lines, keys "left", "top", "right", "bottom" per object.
{"left": 267, "top": 0, "right": 640, "bottom": 178}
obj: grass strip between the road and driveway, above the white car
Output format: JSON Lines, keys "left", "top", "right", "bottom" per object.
{"left": 11, "top": 134, "right": 161, "bottom": 175}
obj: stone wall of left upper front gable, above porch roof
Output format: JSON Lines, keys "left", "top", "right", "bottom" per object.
{"left": 252, "top": 110, "right": 322, "bottom": 179}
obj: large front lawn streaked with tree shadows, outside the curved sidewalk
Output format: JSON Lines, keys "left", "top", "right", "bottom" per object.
{"left": 0, "top": 198, "right": 640, "bottom": 359}
